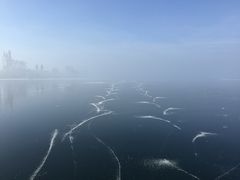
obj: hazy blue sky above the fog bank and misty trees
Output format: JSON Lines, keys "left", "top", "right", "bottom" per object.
{"left": 0, "top": 0, "right": 240, "bottom": 79}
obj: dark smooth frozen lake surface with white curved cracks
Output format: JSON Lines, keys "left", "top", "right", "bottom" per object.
{"left": 0, "top": 80, "right": 240, "bottom": 180}
